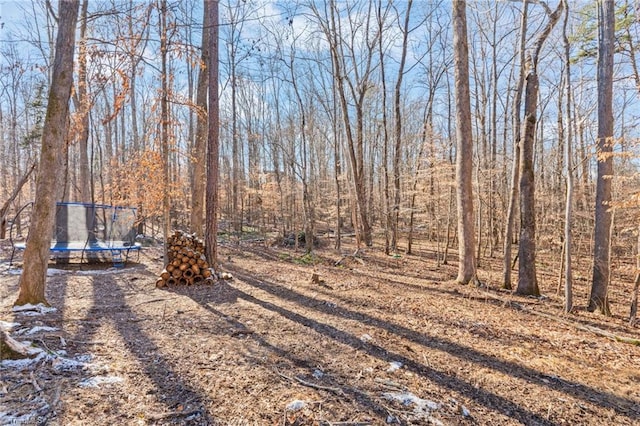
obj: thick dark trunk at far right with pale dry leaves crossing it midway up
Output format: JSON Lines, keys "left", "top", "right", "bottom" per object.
{"left": 587, "top": 0, "right": 615, "bottom": 315}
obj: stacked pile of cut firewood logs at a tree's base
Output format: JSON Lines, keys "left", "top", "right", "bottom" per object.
{"left": 156, "top": 231, "right": 214, "bottom": 287}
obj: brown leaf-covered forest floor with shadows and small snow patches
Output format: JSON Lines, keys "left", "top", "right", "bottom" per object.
{"left": 0, "top": 236, "right": 640, "bottom": 426}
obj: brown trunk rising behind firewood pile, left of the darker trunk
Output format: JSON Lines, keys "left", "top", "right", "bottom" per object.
{"left": 191, "top": 0, "right": 211, "bottom": 236}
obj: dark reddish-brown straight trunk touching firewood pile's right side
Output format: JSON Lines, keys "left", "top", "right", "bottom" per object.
{"left": 205, "top": 0, "right": 220, "bottom": 270}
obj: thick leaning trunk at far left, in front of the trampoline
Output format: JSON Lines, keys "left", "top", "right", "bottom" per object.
{"left": 14, "top": 0, "right": 80, "bottom": 305}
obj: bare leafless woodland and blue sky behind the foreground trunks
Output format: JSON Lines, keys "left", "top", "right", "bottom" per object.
{"left": 0, "top": 0, "right": 640, "bottom": 310}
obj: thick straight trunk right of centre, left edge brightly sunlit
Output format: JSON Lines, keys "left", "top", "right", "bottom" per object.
{"left": 453, "top": 0, "right": 477, "bottom": 284}
